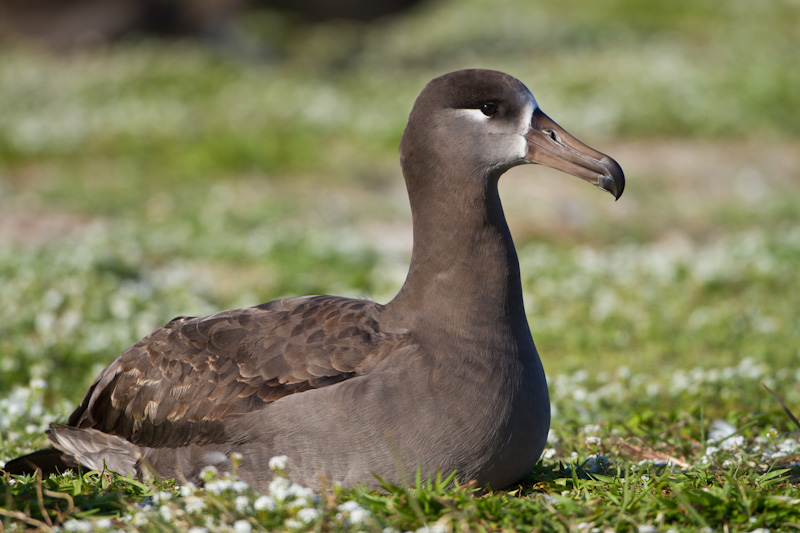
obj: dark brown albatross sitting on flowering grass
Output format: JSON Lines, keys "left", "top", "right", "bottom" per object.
{"left": 5, "top": 70, "right": 625, "bottom": 489}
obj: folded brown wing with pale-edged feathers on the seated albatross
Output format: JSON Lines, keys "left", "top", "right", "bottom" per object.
{"left": 68, "top": 296, "right": 410, "bottom": 447}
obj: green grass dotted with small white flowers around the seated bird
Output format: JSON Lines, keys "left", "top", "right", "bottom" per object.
{"left": 0, "top": 0, "right": 800, "bottom": 532}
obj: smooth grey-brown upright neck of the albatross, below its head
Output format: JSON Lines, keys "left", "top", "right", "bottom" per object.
{"left": 386, "top": 162, "right": 529, "bottom": 339}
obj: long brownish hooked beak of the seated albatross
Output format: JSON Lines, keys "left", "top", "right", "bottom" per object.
{"left": 525, "top": 108, "right": 625, "bottom": 199}
